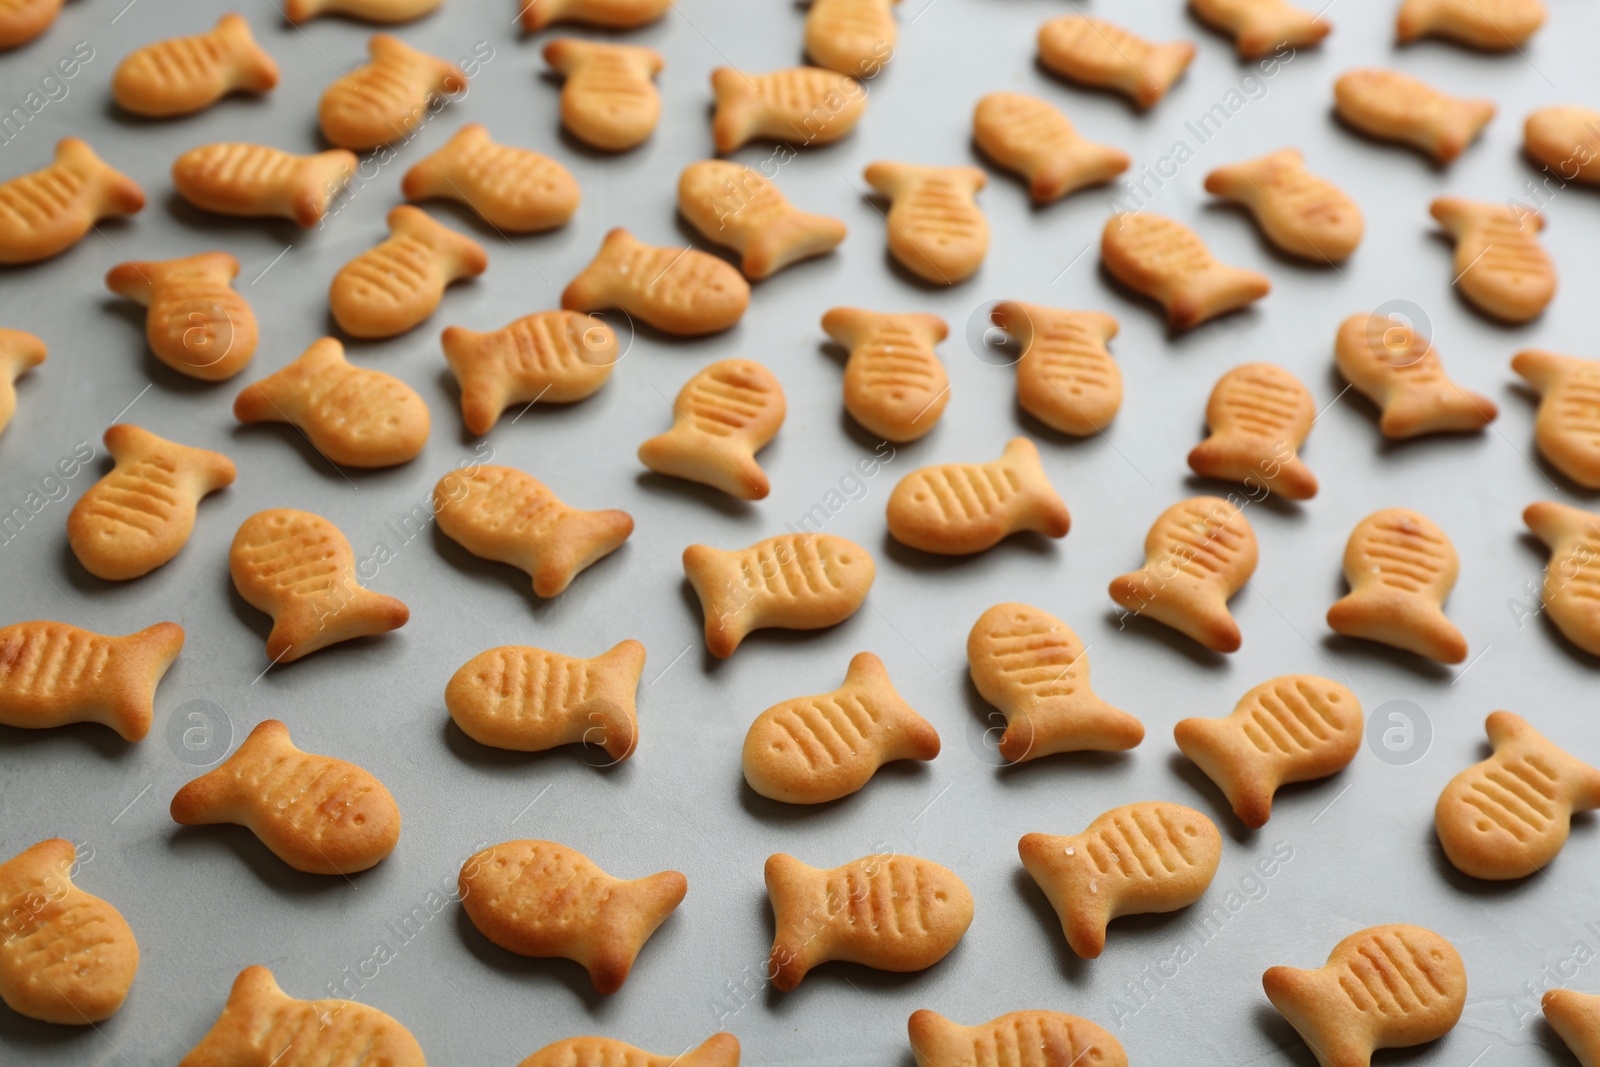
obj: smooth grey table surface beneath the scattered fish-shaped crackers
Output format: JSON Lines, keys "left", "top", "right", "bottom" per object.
{"left": 0, "top": 0, "right": 1600, "bottom": 1067}
